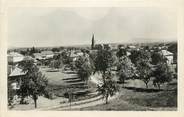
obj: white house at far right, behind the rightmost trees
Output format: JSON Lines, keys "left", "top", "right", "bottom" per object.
{"left": 160, "top": 50, "right": 173, "bottom": 65}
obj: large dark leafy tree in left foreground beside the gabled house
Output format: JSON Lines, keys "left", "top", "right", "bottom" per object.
{"left": 18, "top": 60, "right": 48, "bottom": 108}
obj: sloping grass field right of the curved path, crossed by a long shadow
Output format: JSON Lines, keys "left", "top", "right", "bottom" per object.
{"left": 80, "top": 78, "right": 177, "bottom": 111}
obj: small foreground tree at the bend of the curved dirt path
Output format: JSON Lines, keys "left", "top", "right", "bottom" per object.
{"left": 97, "top": 71, "right": 119, "bottom": 104}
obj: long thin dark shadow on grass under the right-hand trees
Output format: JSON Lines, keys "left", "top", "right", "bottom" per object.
{"left": 123, "top": 87, "right": 163, "bottom": 93}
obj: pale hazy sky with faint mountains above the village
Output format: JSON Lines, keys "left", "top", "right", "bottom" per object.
{"left": 8, "top": 7, "right": 177, "bottom": 47}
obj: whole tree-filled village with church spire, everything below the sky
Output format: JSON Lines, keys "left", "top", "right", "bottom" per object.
{"left": 7, "top": 34, "right": 177, "bottom": 110}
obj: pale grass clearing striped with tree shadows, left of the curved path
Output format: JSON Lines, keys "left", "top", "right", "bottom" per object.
{"left": 40, "top": 67, "right": 96, "bottom": 100}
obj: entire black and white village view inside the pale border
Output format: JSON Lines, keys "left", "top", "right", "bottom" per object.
{"left": 6, "top": 7, "right": 178, "bottom": 111}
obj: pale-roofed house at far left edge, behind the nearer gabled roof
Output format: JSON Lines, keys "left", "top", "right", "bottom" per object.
{"left": 8, "top": 52, "right": 24, "bottom": 63}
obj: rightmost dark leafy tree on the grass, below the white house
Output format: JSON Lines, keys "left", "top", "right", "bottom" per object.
{"left": 153, "top": 62, "right": 172, "bottom": 89}
